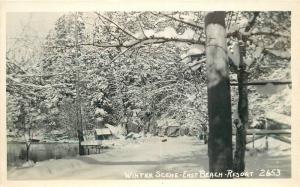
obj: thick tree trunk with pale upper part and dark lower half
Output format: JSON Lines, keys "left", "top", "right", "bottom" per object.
{"left": 205, "top": 12, "right": 232, "bottom": 178}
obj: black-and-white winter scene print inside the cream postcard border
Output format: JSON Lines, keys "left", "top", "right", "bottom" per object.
{"left": 2, "top": 7, "right": 297, "bottom": 180}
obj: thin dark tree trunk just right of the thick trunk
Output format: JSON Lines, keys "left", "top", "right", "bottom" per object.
{"left": 234, "top": 42, "right": 248, "bottom": 173}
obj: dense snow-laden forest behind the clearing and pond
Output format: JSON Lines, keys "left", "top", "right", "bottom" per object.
{"left": 6, "top": 11, "right": 291, "bottom": 178}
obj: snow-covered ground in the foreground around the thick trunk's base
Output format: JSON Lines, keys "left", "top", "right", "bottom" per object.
{"left": 8, "top": 137, "right": 291, "bottom": 179}
